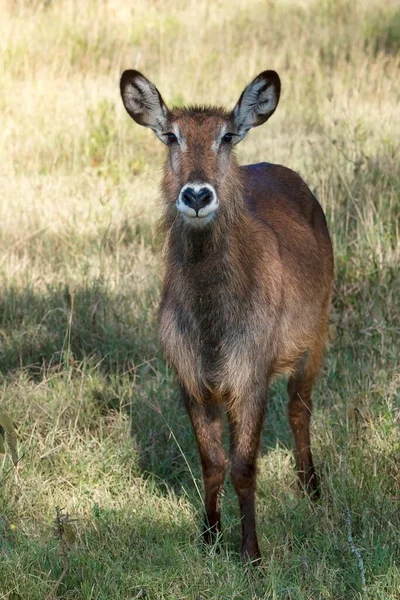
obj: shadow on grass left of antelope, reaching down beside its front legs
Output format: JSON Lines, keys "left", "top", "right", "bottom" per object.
{"left": 0, "top": 282, "right": 203, "bottom": 493}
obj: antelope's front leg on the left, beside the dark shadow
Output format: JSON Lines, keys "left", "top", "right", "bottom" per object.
{"left": 182, "top": 388, "right": 227, "bottom": 543}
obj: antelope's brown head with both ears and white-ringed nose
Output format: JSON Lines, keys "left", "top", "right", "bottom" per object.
{"left": 120, "top": 71, "right": 280, "bottom": 227}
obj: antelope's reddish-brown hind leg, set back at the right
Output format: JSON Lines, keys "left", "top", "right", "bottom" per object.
{"left": 288, "top": 349, "right": 322, "bottom": 499}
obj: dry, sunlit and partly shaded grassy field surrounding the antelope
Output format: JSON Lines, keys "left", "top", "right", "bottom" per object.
{"left": 0, "top": 0, "right": 400, "bottom": 600}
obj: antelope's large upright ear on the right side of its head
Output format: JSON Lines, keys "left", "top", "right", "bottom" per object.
{"left": 232, "top": 71, "right": 281, "bottom": 143}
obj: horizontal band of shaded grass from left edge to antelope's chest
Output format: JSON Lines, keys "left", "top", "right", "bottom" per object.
{"left": 0, "top": 283, "right": 157, "bottom": 377}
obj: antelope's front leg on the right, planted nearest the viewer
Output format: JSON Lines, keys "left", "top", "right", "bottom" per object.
{"left": 228, "top": 391, "right": 267, "bottom": 564}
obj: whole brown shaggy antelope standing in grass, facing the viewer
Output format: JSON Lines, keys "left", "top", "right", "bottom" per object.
{"left": 120, "top": 70, "right": 333, "bottom": 564}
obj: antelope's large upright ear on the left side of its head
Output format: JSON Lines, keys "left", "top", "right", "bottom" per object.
{"left": 120, "top": 70, "right": 168, "bottom": 143}
